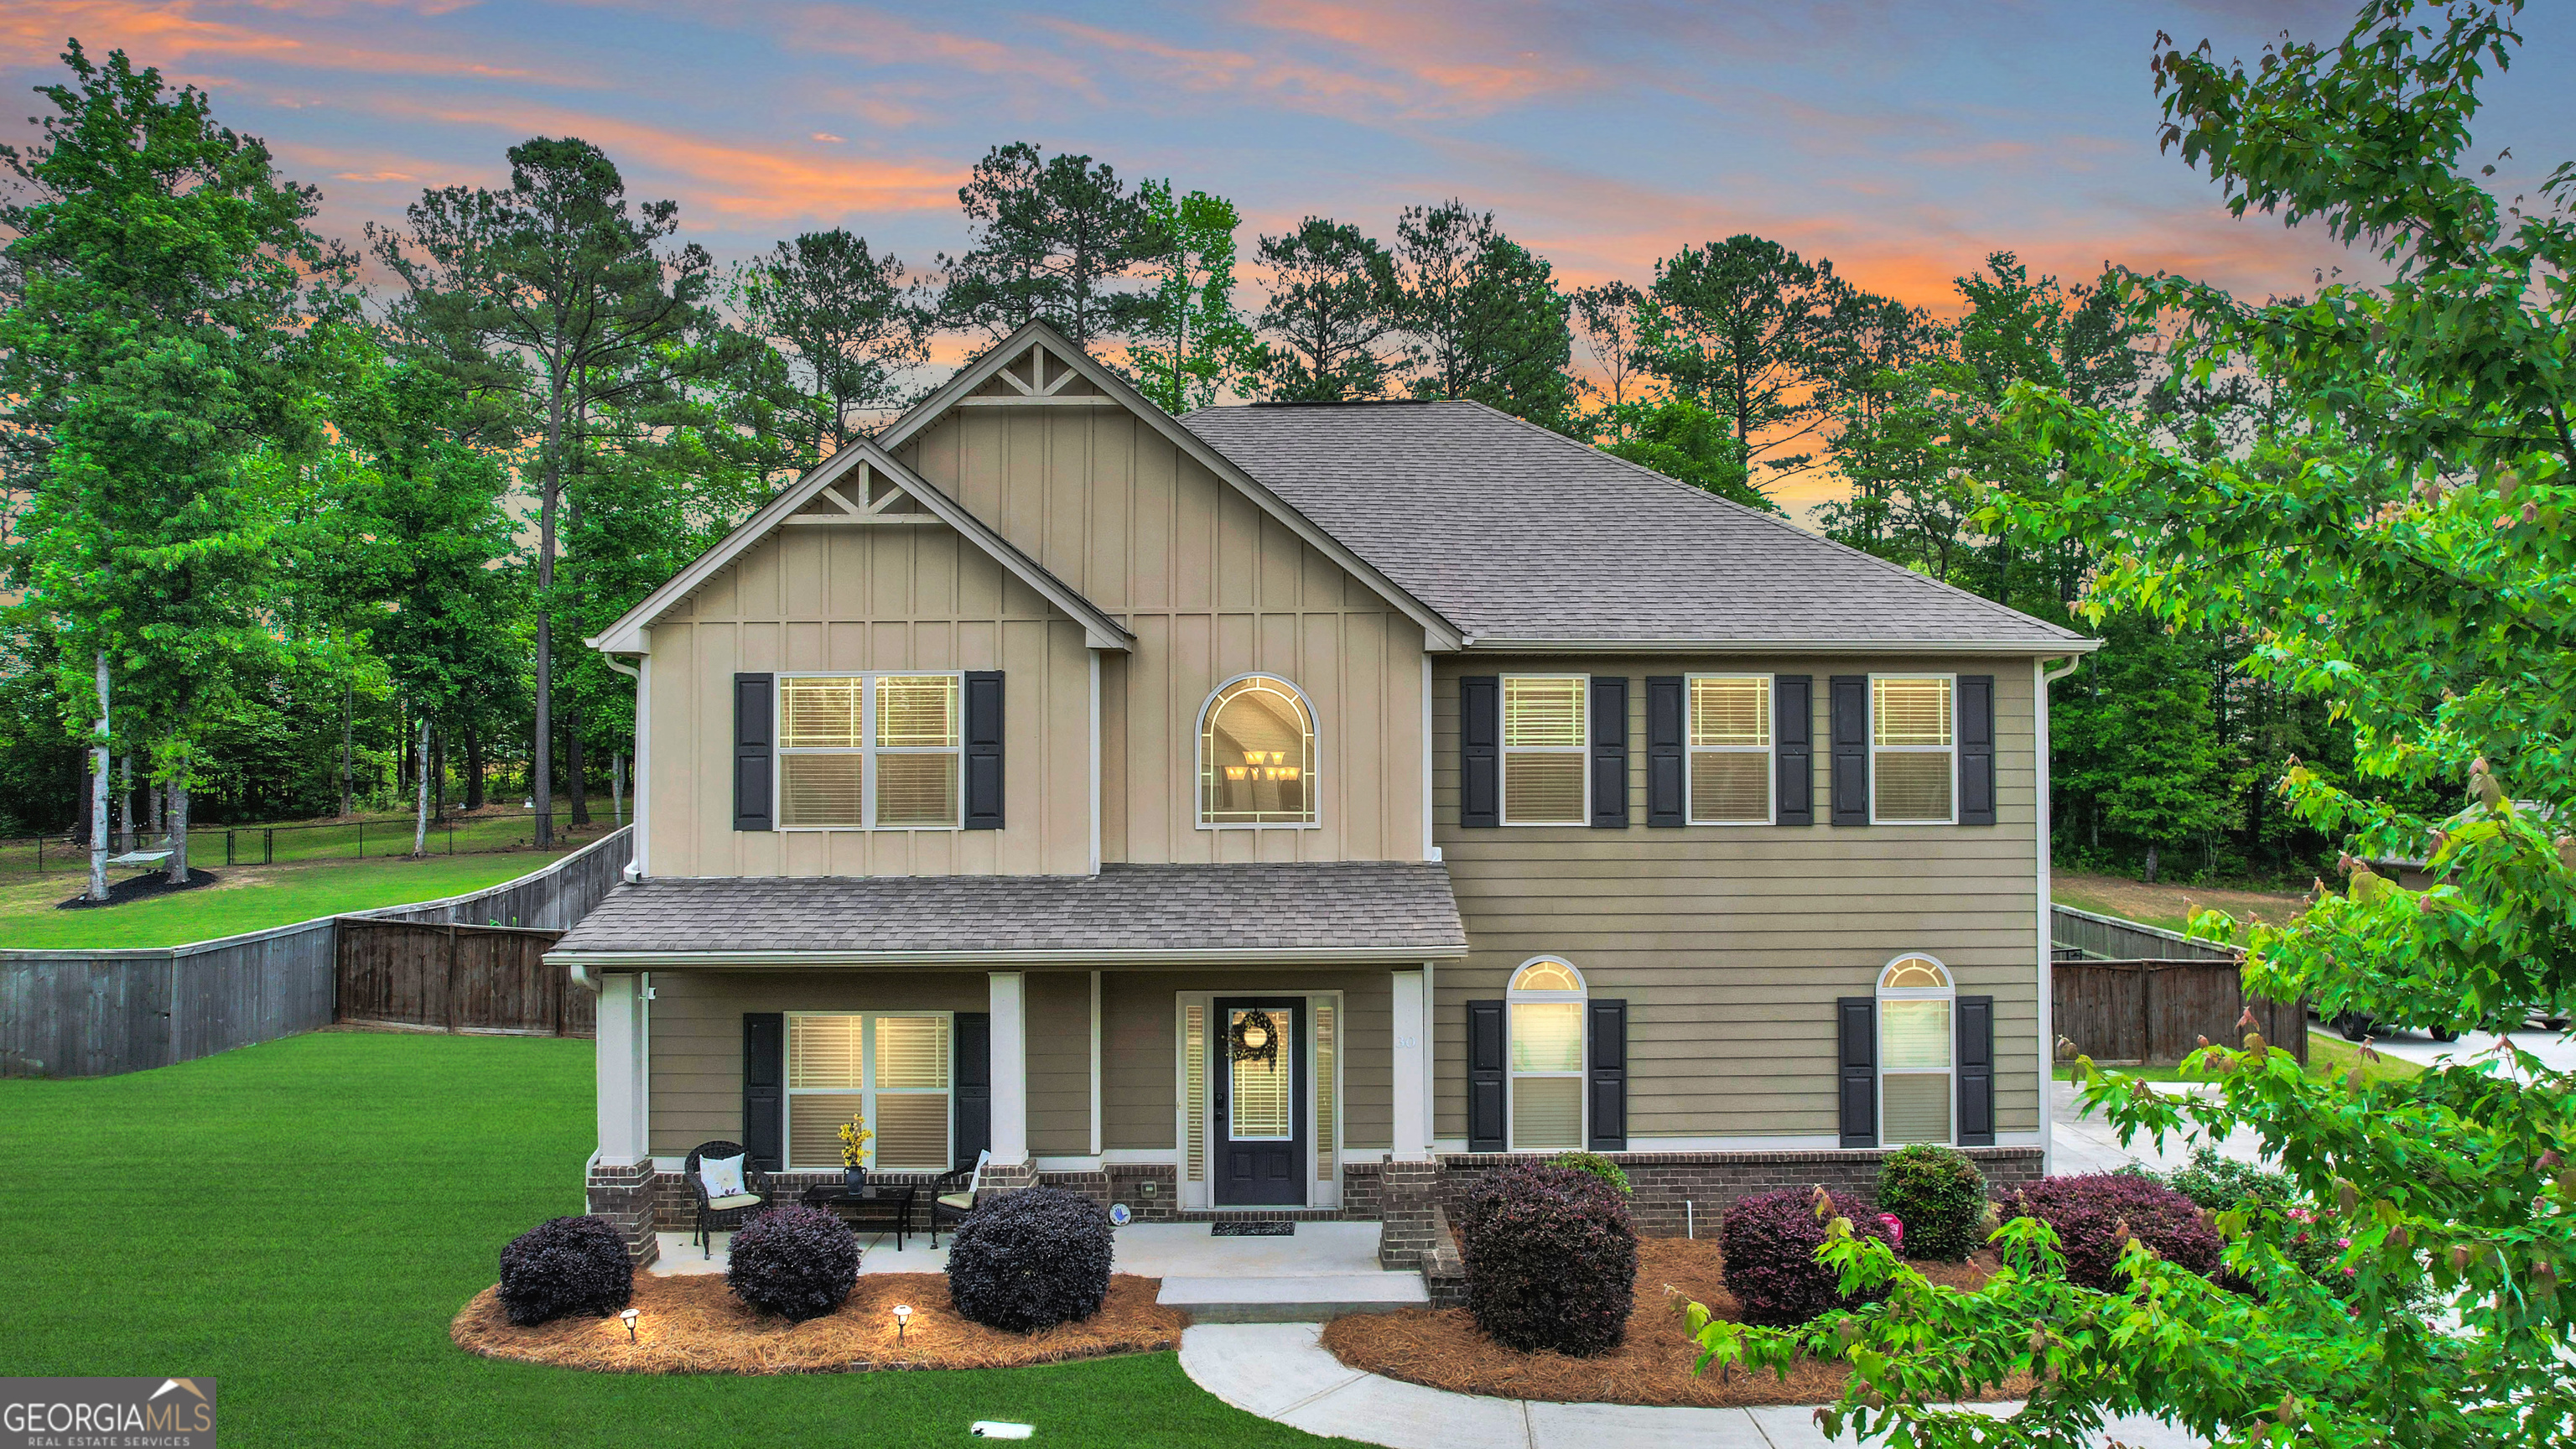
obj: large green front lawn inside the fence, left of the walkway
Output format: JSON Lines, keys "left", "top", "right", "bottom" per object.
{"left": 0, "top": 1031, "right": 1360, "bottom": 1449}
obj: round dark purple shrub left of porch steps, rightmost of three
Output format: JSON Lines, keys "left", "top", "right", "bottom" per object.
{"left": 948, "top": 1188, "right": 1115, "bottom": 1333}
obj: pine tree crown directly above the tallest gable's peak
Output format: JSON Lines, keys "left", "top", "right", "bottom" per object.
{"left": 940, "top": 142, "right": 1154, "bottom": 348}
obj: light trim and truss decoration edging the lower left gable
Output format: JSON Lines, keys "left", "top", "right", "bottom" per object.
{"left": 587, "top": 439, "right": 1136, "bottom": 655}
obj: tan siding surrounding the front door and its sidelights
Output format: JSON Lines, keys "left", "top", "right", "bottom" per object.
{"left": 1100, "top": 969, "right": 1396, "bottom": 1158}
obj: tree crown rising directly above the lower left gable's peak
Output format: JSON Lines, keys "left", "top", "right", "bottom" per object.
{"left": 731, "top": 227, "right": 932, "bottom": 467}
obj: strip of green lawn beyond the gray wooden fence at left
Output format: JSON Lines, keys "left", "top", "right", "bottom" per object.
{"left": 0, "top": 851, "right": 582, "bottom": 952}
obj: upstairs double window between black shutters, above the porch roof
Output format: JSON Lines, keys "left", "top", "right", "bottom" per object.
{"left": 778, "top": 673, "right": 963, "bottom": 830}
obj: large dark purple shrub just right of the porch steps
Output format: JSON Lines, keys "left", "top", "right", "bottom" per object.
{"left": 1458, "top": 1163, "right": 1636, "bottom": 1353}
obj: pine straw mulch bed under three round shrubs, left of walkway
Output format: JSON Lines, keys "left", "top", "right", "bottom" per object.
{"left": 449, "top": 1274, "right": 1190, "bottom": 1374}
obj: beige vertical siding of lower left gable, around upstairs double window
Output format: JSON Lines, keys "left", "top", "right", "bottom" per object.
{"left": 644, "top": 523, "right": 1093, "bottom": 876}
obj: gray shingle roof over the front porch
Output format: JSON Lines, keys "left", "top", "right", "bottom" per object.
{"left": 548, "top": 861, "right": 1466, "bottom": 959}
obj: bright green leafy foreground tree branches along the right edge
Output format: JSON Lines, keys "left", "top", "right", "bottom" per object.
{"left": 1695, "top": 0, "right": 2576, "bottom": 1449}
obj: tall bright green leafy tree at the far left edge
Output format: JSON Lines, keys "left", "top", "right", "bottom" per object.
{"left": 0, "top": 41, "right": 348, "bottom": 879}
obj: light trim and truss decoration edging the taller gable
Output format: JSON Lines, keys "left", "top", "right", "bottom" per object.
{"left": 875, "top": 322, "right": 1461, "bottom": 652}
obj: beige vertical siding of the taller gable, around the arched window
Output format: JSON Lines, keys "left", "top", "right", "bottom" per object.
{"left": 901, "top": 379, "right": 1422, "bottom": 864}
